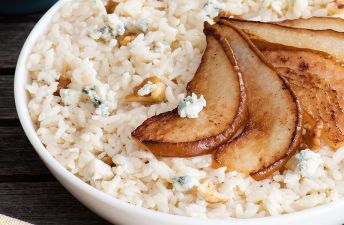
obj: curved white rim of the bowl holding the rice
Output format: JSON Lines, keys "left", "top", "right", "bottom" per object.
{"left": 14, "top": 0, "right": 344, "bottom": 225}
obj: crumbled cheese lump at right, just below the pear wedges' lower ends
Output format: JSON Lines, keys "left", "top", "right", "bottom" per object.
{"left": 295, "top": 149, "right": 324, "bottom": 178}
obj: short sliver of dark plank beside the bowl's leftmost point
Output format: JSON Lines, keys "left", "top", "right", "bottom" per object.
{"left": 0, "top": 75, "right": 18, "bottom": 119}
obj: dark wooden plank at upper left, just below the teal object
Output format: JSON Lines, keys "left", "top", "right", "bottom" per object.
{"left": 0, "top": 14, "right": 42, "bottom": 69}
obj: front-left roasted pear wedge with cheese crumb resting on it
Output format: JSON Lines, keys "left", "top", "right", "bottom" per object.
{"left": 132, "top": 34, "right": 248, "bottom": 157}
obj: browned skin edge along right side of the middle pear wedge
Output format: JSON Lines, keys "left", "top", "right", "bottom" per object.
{"left": 206, "top": 19, "right": 303, "bottom": 180}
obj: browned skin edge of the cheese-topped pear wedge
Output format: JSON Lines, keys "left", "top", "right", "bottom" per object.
{"left": 131, "top": 30, "right": 248, "bottom": 157}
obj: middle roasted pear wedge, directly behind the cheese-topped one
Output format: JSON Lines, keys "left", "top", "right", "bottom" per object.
{"left": 206, "top": 23, "right": 302, "bottom": 180}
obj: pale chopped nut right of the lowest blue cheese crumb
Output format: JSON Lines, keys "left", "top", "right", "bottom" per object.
{"left": 197, "top": 181, "right": 229, "bottom": 203}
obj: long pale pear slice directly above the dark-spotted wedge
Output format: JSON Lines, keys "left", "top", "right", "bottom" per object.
{"left": 216, "top": 17, "right": 344, "bottom": 60}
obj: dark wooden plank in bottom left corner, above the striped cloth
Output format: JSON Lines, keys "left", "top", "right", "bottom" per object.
{"left": 0, "top": 182, "right": 109, "bottom": 225}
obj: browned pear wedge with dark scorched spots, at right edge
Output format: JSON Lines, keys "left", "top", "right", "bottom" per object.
{"left": 253, "top": 40, "right": 344, "bottom": 149}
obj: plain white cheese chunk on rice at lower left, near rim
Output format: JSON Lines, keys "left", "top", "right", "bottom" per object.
{"left": 80, "top": 158, "right": 114, "bottom": 181}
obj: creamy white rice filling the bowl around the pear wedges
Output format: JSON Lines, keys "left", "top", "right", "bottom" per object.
{"left": 27, "top": 0, "right": 344, "bottom": 218}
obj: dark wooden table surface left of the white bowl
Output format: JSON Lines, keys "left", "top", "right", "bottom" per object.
{"left": 0, "top": 13, "right": 109, "bottom": 225}
